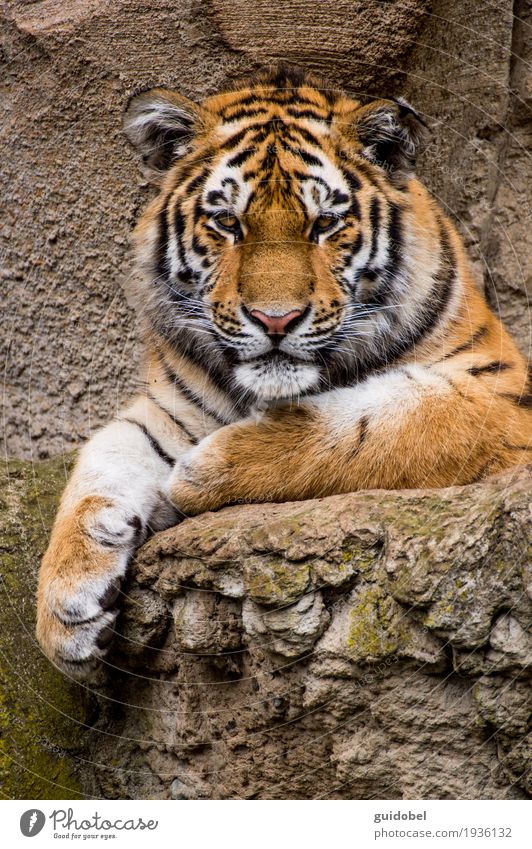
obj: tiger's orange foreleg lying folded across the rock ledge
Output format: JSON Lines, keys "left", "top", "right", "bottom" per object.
{"left": 170, "top": 365, "right": 530, "bottom": 514}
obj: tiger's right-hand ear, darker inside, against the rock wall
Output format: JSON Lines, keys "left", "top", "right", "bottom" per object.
{"left": 354, "top": 98, "right": 430, "bottom": 183}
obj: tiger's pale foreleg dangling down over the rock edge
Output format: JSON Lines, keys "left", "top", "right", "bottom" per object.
{"left": 37, "top": 397, "right": 197, "bottom": 676}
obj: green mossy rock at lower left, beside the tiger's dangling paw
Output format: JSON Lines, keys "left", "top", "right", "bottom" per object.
{"left": 0, "top": 456, "right": 91, "bottom": 799}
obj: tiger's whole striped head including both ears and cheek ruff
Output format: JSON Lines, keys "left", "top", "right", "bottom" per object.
{"left": 125, "top": 69, "right": 437, "bottom": 401}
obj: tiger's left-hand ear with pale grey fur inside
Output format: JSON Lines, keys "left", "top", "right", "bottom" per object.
{"left": 124, "top": 88, "right": 205, "bottom": 182}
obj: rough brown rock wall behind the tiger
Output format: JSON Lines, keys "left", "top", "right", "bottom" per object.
{"left": 0, "top": 0, "right": 532, "bottom": 457}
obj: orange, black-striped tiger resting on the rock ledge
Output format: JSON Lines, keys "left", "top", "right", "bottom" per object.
{"left": 37, "top": 67, "right": 531, "bottom": 677}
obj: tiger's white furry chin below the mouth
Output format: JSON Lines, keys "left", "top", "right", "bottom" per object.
{"left": 235, "top": 356, "right": 320, "bottom": 401}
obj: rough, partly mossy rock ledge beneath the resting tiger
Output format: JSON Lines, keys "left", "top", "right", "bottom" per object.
{"left": 4, "top": 460, "right": 532, "bottom": 799}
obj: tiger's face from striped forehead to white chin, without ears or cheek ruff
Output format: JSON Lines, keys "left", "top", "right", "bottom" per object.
{"left": 183, "top": 112, "right": 357, "bottom": 400}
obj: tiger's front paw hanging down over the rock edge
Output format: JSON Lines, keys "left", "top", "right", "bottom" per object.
{"left": 37, "top": 497, "right": 142, "bottom": 678}
